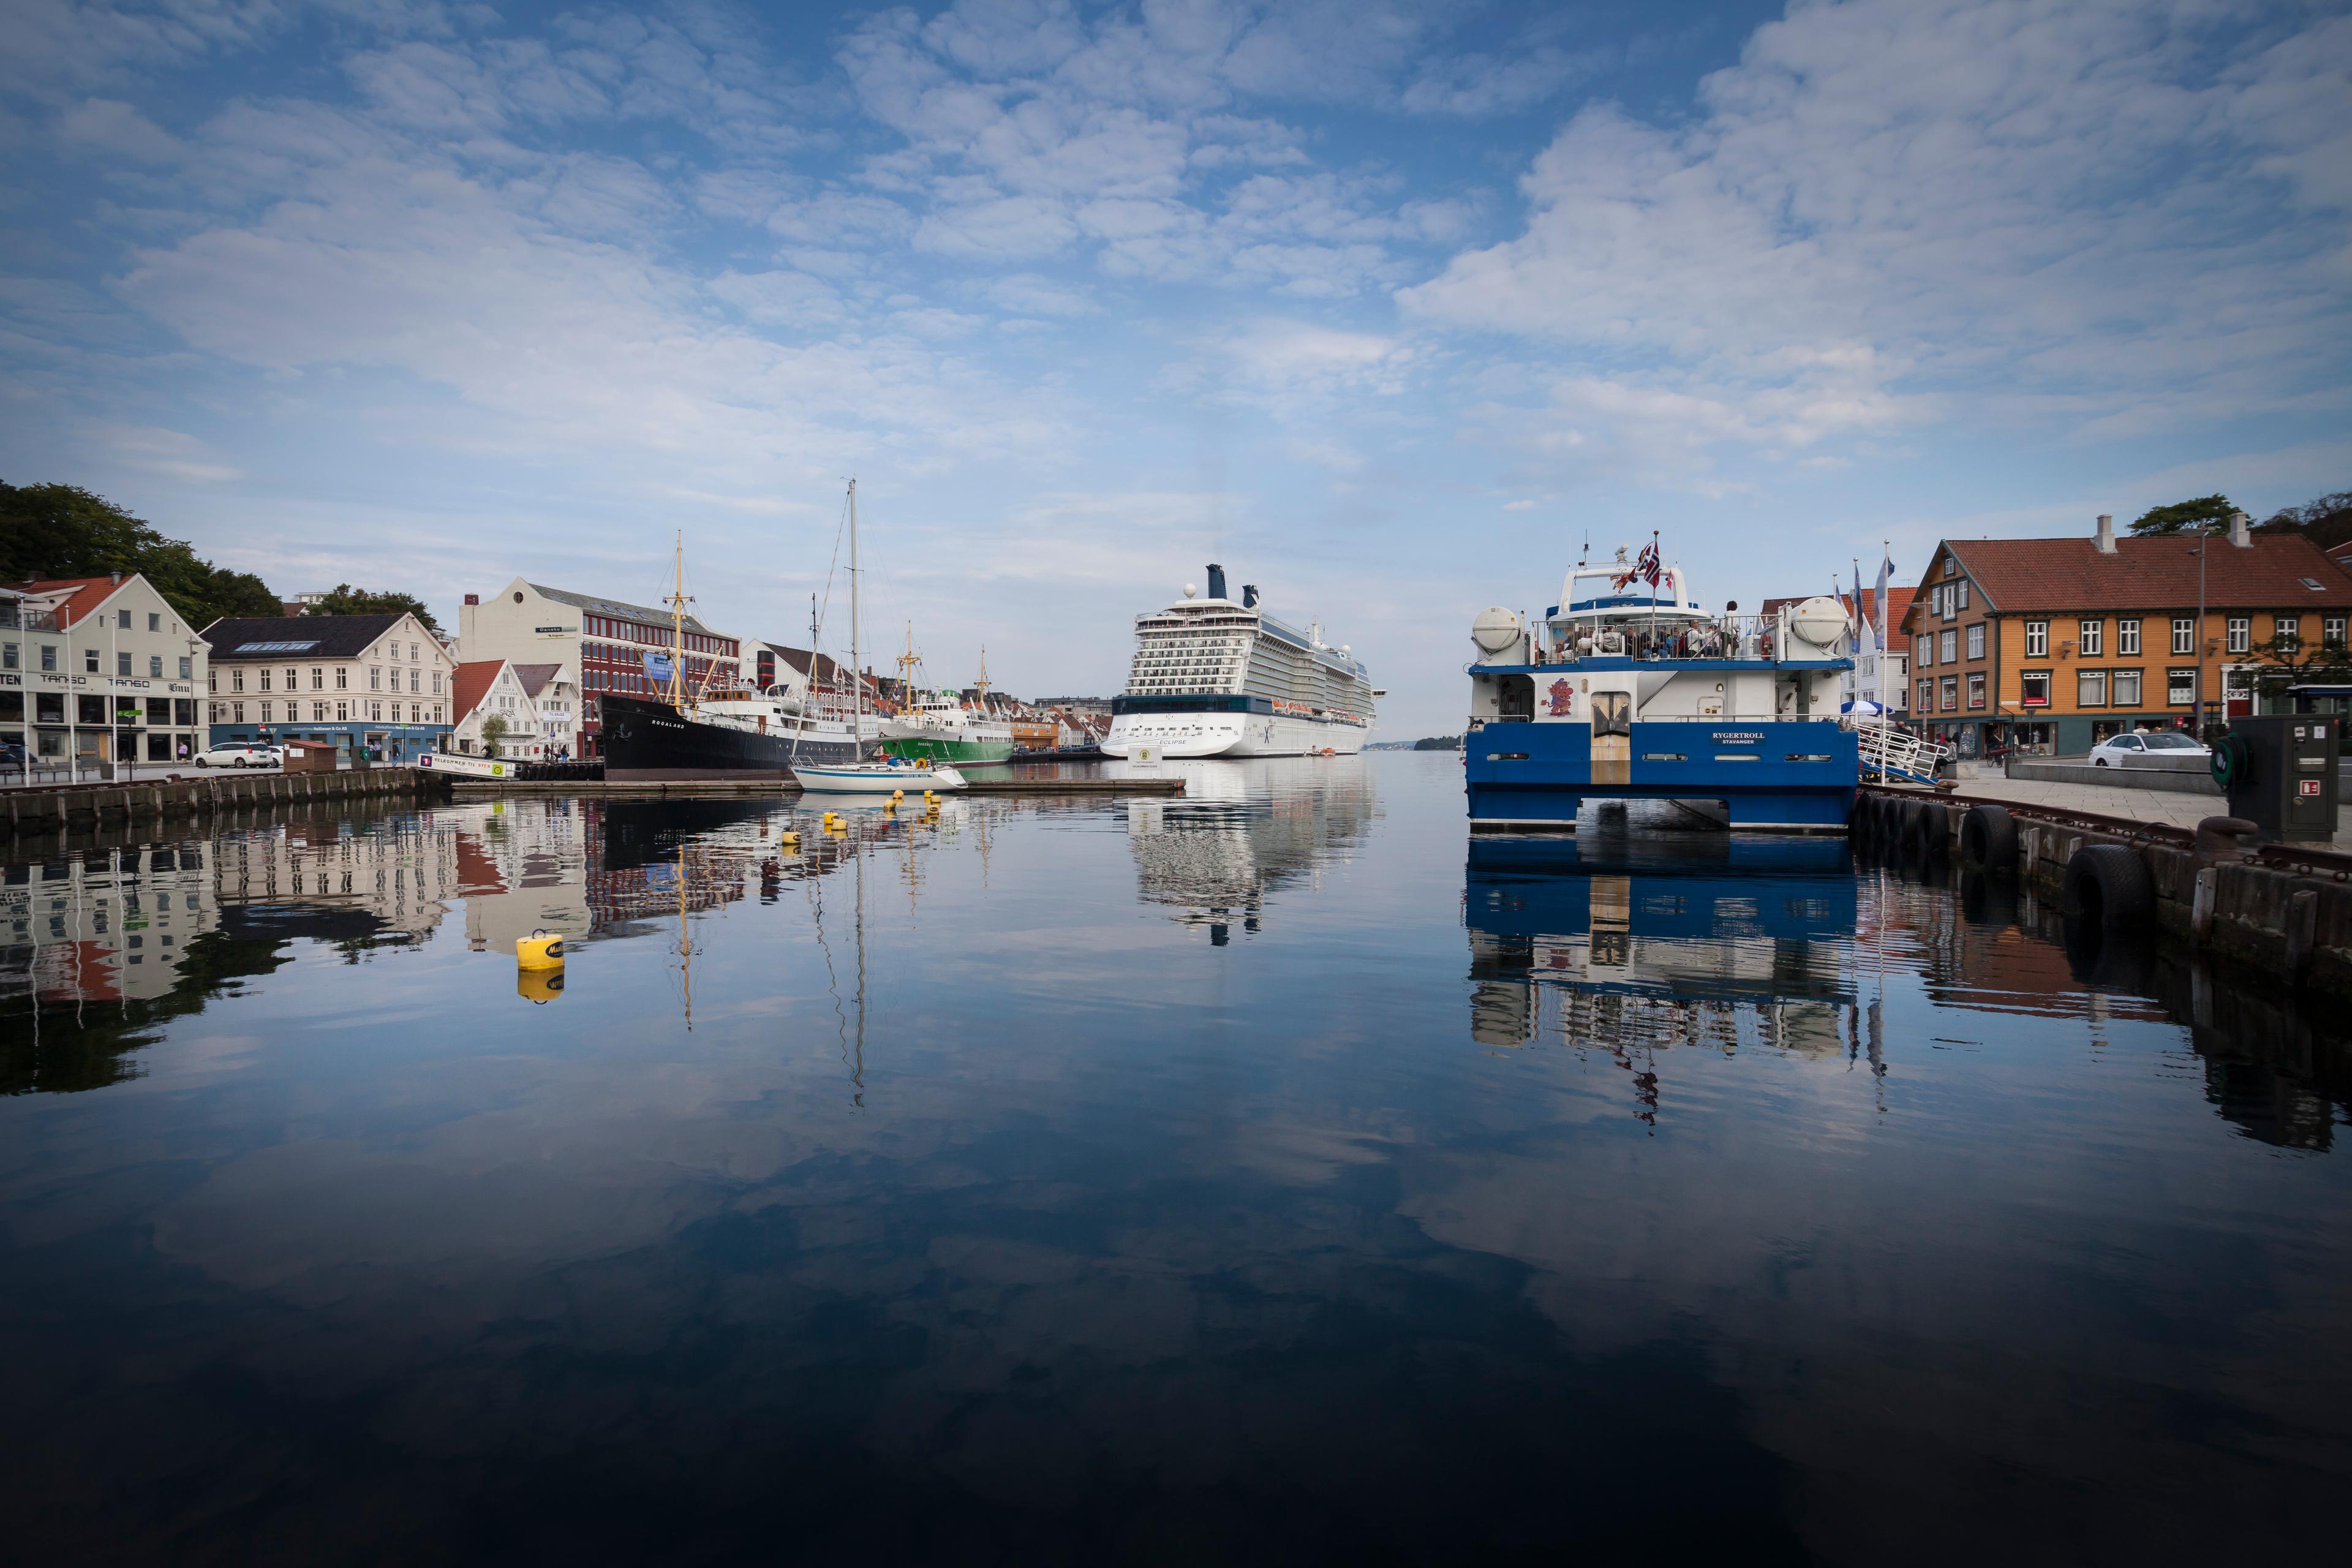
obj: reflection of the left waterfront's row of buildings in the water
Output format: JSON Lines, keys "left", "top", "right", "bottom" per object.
{"left": 0, "top": 797, "right": 962, "bottom": 1093}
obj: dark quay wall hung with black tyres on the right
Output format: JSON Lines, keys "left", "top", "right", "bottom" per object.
{"left": 1851, "top": 780, "right": 2352, "bottom": 997}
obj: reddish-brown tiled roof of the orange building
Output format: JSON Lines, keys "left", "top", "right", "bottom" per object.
{"left": 1898, "top": 533, "right": 2352, "bottom": 625}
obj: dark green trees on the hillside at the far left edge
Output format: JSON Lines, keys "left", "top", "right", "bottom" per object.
{"left": 0, "top": 482, "right": 277, "bottom": 630}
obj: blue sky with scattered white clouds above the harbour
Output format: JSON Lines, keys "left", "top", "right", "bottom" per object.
{"left": 0, "top": 0, "right": 2352, "bottom": 738}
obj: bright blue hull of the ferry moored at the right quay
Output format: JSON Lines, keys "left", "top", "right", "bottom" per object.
{"left": 1463, "top": 719, "right": 1860, "bottom": 832}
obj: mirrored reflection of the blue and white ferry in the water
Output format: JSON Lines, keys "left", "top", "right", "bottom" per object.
{"left": 1463, "top": 832, "right": 1879, "bottom": 1124}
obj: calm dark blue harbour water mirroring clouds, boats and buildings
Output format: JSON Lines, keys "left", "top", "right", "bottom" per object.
{"left": 0, "top": 755, "right": 2352, "bottom": 1563}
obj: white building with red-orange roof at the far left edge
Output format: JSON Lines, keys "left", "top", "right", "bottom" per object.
{"left": 0, "top": 571, "right": 209, "bottom": 771}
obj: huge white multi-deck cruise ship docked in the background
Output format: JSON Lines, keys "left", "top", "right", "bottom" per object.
{"left": 1103, "top": 564, "right": 1388, "bottom": 757}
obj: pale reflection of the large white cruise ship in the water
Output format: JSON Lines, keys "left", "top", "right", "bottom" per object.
{"left": 1126, "top": 757, "right": 1378, "bottom": 948}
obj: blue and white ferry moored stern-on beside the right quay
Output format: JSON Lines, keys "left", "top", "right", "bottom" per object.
{"left": 1463, "top": 562, "right": 1858, "bottom": 832}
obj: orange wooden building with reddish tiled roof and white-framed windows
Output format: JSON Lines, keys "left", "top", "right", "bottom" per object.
{"left": 1898, "top": 513, "right": 2352, "bottom": 757}
